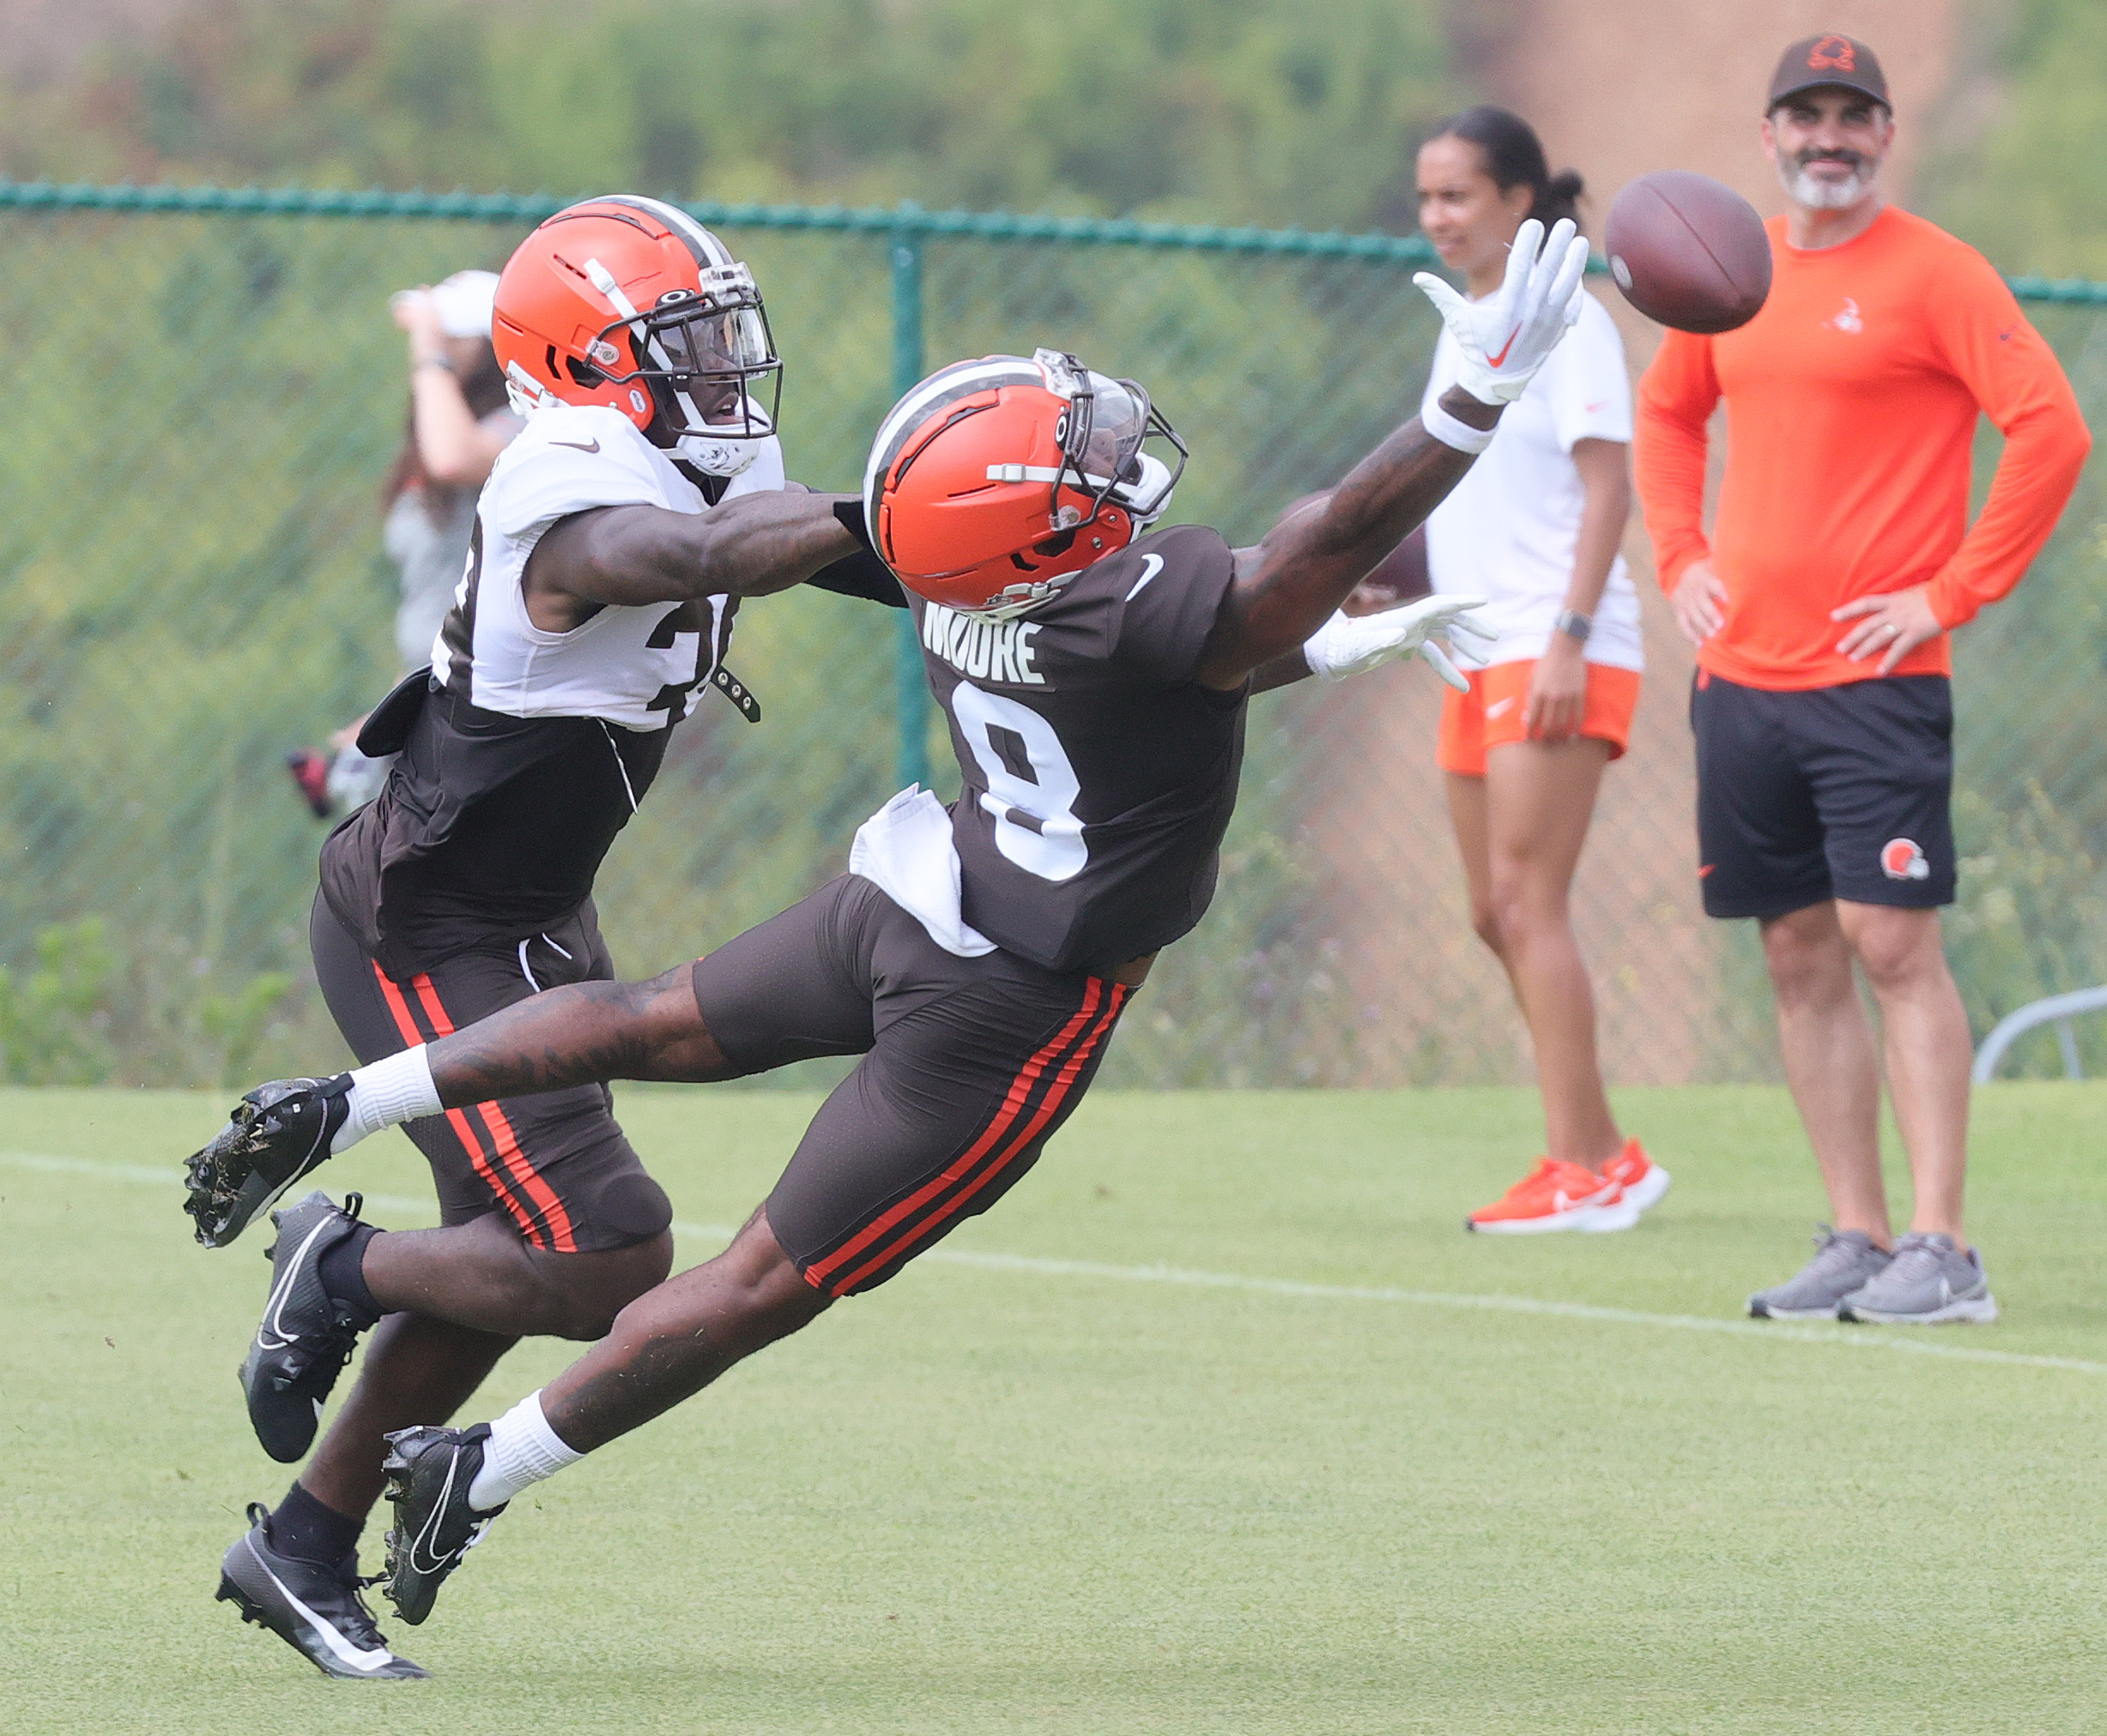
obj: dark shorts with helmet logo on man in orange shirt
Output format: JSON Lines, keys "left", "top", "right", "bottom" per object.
{"left": 1690, "top": 672, "right": 1953, "bottom": 916}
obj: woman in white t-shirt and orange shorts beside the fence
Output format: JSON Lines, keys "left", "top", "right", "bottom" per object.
{"left": 1418, "top": 107, "right": 1668, "bottom": 1235}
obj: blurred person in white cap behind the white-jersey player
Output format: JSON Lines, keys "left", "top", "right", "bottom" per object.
{"left": 287, "top": 272, "right": 520, "bottom": 820}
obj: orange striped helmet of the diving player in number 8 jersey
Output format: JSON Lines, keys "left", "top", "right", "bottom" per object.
{"left": 864, "top": 350, "right": 1186, "bottom": 620}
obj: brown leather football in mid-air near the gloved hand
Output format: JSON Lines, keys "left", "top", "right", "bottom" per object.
{"left": 1603, "top": 168, "right": 1770, "bottom": 333}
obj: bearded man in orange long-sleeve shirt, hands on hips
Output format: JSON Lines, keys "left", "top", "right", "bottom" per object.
{"left": 1635, "top": 36, "right": 2090, "bottom": 1323}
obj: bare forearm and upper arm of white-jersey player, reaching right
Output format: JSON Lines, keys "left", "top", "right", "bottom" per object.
{"left": 524, "top": 489, "right": 862, "bottom": 632}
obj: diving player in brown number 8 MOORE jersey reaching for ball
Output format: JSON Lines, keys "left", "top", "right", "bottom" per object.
{"left": 189, "top": 223, "right": 1587, "bottom": 1622}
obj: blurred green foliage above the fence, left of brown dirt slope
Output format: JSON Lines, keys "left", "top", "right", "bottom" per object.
{"left": 0, "top": 0, "right": 1454, "bottom": 227}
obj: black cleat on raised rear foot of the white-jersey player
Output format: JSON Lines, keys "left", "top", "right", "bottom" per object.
{"left": 240, "top": 1189, "right": 371, "bottom": 1464}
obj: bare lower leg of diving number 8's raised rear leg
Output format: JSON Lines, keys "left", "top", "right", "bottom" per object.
{"left": 426, "top": 965, "right": 737, "bottom": 1108}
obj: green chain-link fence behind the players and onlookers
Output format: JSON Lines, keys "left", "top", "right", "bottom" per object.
{"left": 0, "top": 185, "right": 2107, "bottom": 1085}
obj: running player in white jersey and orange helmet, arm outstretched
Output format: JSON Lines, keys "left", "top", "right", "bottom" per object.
{"left": 187, "top": 198, "right": 904, "bottom": 1677}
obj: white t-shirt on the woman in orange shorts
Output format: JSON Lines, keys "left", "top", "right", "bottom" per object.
{"left": 1422, "top": 295, "right": 1645, "bottom": 670}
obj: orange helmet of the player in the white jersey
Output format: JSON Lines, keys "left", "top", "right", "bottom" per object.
{"left": 491, "top": 194, "right": 782, "bottom": 476}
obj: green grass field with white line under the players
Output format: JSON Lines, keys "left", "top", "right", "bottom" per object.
{"left": 0, "top": 1085, "right": 2107, "bottom": 1736}
